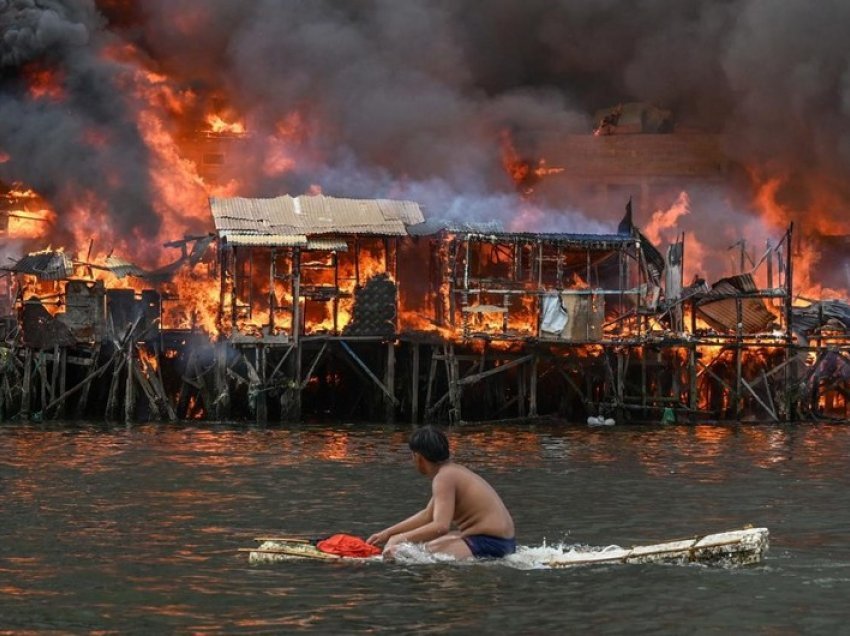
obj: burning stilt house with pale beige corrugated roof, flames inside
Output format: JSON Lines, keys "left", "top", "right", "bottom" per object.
{"left": 211, "top": 195, "right": 424, "bottom": 343}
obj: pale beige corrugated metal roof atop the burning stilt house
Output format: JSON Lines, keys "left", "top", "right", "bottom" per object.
{"left": 210, "top": 195, "right": 424, "bottom": 236}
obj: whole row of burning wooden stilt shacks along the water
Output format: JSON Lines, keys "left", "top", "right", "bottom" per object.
{"left": 0, "top": 195, "right": 850, "bottom": 422}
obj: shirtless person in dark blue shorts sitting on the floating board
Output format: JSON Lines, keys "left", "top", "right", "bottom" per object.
{"left": 367, "top": 426, "right": 516, "bottom": 559}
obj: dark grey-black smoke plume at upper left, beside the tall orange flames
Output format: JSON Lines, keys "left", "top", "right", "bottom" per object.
{"left": 0, "top": 0, "right": 160, "bottom": 246}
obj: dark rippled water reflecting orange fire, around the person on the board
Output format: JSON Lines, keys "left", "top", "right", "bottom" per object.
{"left": 0, "top": 424, "right": 850, "bottom": 634}
